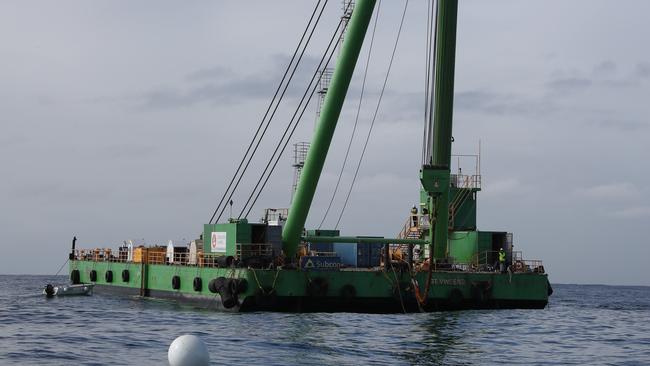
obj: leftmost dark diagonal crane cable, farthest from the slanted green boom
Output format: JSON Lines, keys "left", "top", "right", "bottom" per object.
{"left": 208, "top": 0, "right": 329, "bottom": 223}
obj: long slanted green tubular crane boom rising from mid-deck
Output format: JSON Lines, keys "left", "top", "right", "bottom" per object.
{"left": 282, "top": 0, "right": 375, "bottom": 258}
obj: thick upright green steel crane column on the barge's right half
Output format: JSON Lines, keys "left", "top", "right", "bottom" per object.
{"left": 431, "top": 0, "right": 458, "bottom": 258}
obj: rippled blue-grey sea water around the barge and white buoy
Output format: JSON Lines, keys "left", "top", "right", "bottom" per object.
{"left": 0, "top": 276, "right": 650, "bottom": 365}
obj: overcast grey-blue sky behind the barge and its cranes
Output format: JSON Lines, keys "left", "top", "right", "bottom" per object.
{"left": 0, "top": 0, "right": 650, "bottom": 285}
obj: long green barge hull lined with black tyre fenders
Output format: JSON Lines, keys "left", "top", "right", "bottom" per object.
{"left": 69, "top": 260, "right": 551, "bottom": 313}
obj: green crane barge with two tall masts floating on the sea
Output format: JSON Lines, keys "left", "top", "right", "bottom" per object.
{"left": 69, "top": 0, "right": 552, "bottom": 313}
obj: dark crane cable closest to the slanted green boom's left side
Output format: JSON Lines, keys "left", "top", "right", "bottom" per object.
{"left": 237, "top": 3, "right": 351, "bottom": 219}
